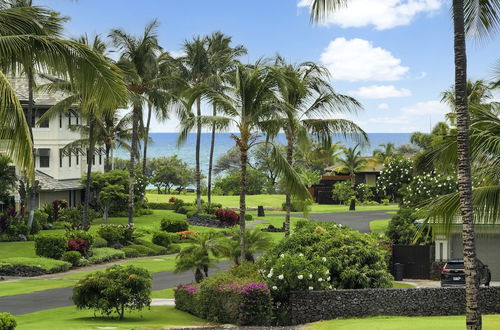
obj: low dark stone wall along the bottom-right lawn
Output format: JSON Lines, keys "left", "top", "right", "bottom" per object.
{"left": 290, "top": 287, "right": 500, "bottom": 325}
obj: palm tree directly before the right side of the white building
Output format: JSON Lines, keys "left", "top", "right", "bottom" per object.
{"left": 40, "top": 36, "right": 127, "bottom": 228}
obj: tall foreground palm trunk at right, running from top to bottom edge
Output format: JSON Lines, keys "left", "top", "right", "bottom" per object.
{"left": 453, "top": 0, "right": 482, "bottom": 330}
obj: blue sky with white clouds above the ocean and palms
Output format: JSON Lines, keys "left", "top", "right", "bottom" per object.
{"left": 34, "top": 0, "right": 500, "bottom": 133}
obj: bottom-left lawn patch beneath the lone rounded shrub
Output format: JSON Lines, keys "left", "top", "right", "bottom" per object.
{"left": 16, "top": 306, "right": 208, "bottom": 330}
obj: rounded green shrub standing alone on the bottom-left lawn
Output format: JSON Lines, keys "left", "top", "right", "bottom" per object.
{"left": 72, "top": 265, "right": 151, "bottom": 319}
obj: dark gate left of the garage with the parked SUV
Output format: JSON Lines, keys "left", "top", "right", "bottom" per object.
{"left": 392, "top": 245, "right": 434, "bottom": 280}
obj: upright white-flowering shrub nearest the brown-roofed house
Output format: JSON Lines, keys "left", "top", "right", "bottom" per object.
{"left": 377, "top": 157, "right": 413, "bottom": 201}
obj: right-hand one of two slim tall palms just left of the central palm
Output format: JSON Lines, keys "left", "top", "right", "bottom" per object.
{"left": 205, "top": 32, "right": 247, "bottom": 205}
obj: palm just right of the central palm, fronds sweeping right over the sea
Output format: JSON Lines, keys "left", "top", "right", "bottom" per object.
{"left": 270, "top": 57, "right": 367, "bottom": 236}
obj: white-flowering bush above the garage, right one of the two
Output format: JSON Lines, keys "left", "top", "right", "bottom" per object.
{"left": 402, "top": 171, "right": 458, "bottom": 208}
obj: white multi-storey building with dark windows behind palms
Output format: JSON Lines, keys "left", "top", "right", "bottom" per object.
{"left": 10, "top": 78, "right": 104, "bottom": 206}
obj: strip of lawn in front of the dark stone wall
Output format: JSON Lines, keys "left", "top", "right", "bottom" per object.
{"left": 306, "top": 315, "right": 500, "bottom": 330}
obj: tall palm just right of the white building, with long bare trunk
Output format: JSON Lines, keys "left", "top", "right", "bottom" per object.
{"left": 110, "top": 20, "right": 161, "bottom": 224}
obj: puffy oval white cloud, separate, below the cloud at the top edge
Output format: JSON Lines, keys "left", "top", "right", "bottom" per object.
{"left": 320, "top": 38, "right": 409, "bottom": 81}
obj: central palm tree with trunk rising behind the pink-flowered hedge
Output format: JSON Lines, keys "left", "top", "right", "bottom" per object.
{"left": 179, "top": 62, "right": 310, "bottom": 260}
